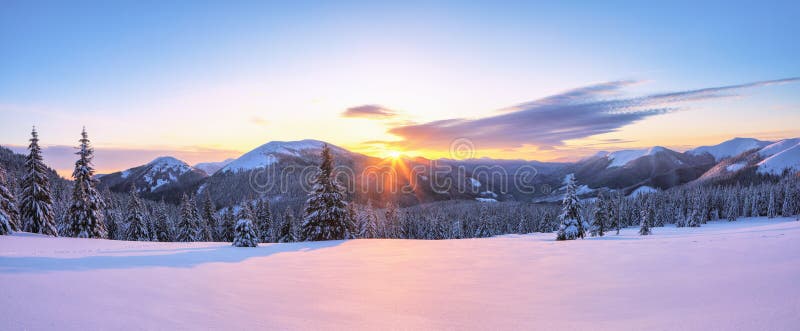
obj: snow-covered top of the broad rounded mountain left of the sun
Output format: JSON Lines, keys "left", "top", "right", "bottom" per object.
{"left": 220, "top": 139, "right": 340, "bottom": 172}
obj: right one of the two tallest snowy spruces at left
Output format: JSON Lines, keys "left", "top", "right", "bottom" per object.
{"left": 67, "top": 128, "right": 107, "bottom": 238}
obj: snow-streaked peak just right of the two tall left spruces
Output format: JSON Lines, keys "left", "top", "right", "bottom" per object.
{"left": 99, "top": 156, "right": 208, "bottom": 202}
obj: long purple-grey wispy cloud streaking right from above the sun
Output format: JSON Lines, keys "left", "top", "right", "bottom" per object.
{"left": 382, "top": 78, "right": 800, "bottom": 149}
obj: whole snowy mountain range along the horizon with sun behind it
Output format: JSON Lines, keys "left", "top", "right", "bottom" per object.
{"left": 87, "top": 138, "right": 800, "bottom": 206}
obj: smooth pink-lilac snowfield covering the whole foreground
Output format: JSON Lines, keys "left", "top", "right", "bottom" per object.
{"left": 0, "top": 218, "right": 800, "bottom": 330}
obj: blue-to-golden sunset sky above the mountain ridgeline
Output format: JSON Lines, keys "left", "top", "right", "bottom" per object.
{"left": 0, "top": 0, "right": 800, "bottom": 174}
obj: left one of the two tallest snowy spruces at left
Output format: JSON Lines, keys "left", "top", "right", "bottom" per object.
{"left": 20, "top": 128, "right": 58, "bottom": 237}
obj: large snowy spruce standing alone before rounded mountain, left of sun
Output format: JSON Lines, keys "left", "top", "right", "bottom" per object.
{"left": 302, "top": 145, "right": 348, "bottom": 241}
